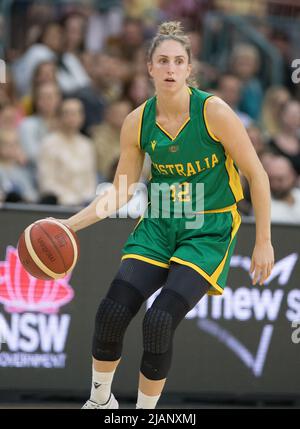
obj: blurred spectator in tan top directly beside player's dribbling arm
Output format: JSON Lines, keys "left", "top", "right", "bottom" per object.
{"left": 91, "top": 100, "right": 132, "bottom": 180}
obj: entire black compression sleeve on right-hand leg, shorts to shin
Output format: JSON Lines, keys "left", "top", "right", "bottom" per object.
{"left": 141, "top": 264, "right": 210, "bottom": 380}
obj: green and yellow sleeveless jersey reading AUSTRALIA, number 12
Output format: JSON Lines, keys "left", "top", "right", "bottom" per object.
{"left": 139, "top": 88, "right": 243, "bottom": 214}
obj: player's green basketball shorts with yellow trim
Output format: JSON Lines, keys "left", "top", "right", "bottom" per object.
{"left": 122, "top": 205, "right": 241, "bottom": 295}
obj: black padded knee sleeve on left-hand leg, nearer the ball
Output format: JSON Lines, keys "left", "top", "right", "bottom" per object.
{"left": 92, "top": 280, "right": 144, "bottom": 361}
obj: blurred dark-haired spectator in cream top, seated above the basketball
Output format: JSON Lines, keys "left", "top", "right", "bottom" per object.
{"left": 38, "top": 98, "right": 96, "bottom": 205}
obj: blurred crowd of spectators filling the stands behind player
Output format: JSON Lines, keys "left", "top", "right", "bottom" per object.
{"left": 0, "top": 0, "right": 300, "bottom": 222}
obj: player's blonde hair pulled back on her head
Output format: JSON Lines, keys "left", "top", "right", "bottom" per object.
{"left": 148, "top": 21, "right": 192, "bottom": 63}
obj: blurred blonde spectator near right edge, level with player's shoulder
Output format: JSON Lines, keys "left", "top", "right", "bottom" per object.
{"left": 261, "top": 86, "right": 291, "bottom": 137}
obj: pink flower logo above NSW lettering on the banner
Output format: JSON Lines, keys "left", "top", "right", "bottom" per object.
{"left": 0, "top": 246, "right": 74, "bottom": 314}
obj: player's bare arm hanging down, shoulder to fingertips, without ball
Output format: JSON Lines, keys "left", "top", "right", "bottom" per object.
{"left": 206, "top": 97, "right": 274, "bottom": 284}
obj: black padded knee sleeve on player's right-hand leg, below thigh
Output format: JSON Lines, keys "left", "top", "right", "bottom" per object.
{"left": 141, "top": 290, "right": 189, "bottom": 380}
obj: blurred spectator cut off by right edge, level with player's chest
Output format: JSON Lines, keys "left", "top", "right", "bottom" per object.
{"left": 270, "top": 99, "right": 300, "bottom": 174}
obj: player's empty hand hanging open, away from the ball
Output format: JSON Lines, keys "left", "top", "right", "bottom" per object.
{"left": 250, "top": 240, "right": 274, "bottom": 285}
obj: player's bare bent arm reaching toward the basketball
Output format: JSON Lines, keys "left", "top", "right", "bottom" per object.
{"left": 64, "top": 106, "right": 144, "bottom": 231}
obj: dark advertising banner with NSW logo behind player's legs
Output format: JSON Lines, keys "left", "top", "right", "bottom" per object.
{"left": 0, "top": 209, "right": 300, "bottom": 397}
